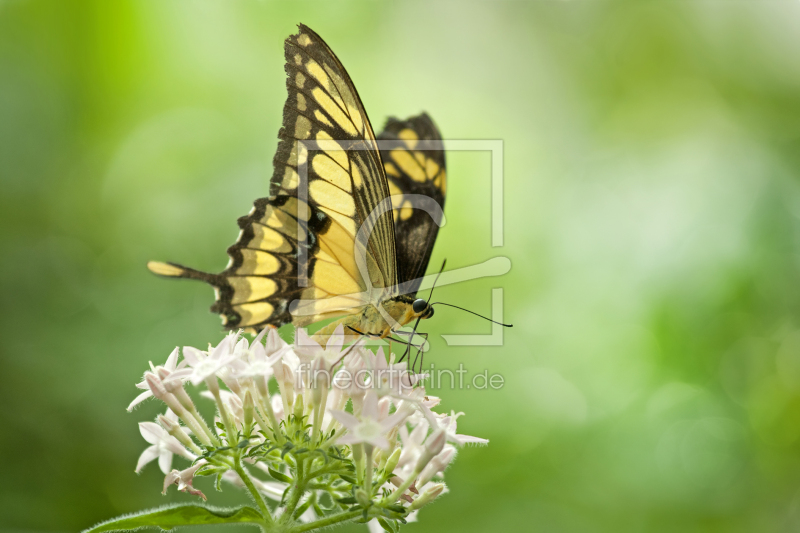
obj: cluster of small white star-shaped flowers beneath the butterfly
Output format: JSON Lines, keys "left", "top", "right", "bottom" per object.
{"left": 128, "top": 327, "right": 488, "bottom": 531}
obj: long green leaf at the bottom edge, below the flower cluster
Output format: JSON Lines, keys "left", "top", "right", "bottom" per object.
{"left": 83, "top": 504, "right": 264, "bottom": 533}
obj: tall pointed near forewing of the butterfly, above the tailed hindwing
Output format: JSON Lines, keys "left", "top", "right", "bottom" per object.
{"left": 271, "top": 25, "right": 396, "bottom": 287}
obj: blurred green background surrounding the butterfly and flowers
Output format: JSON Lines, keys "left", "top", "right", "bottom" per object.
{"left": 0, "top": 0, "right": 800, "bottom": 532}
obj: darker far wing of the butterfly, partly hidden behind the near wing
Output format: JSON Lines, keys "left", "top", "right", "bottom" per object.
{"left": 378, "top": 113, "right": 447, "bottom": 296}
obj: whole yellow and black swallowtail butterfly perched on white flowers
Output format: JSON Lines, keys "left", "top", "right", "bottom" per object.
{"left": 147, "top": 24, "right": 447, "bottom": 352}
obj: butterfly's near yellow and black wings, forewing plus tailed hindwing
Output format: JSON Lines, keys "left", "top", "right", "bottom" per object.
{"left": 148, "top": 25, "right": 397, "bottom": 330}
